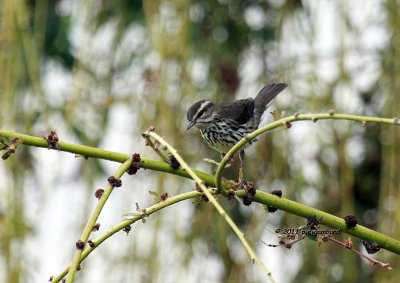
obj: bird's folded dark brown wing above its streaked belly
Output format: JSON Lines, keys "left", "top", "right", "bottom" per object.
{"left": 218, "top": 97, "right": 254, "bottom": 125}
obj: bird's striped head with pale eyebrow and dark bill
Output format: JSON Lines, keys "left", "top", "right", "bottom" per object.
{"left": 186, "top": 99, "right": 214, "bottom": 130}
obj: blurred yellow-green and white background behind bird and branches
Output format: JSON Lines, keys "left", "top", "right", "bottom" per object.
{"left": 0, "top": 0, "right": 400, "bottom": 282}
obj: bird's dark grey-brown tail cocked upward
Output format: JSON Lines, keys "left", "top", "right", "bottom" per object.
{"left": 254, "top": 83, "right": 287, "bottom": 125}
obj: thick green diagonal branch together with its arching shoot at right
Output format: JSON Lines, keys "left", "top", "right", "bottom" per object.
{"left": 0, "top": 116, "right": 400, "bottom": 260}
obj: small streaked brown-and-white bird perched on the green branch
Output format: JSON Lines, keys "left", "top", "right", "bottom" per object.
{"left": 186, "top": 83, "right": 287, "bottom": 182}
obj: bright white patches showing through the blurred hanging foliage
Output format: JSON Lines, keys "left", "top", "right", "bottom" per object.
{"left": 0, "top": 0, "right": 388, "bottom": 283}
